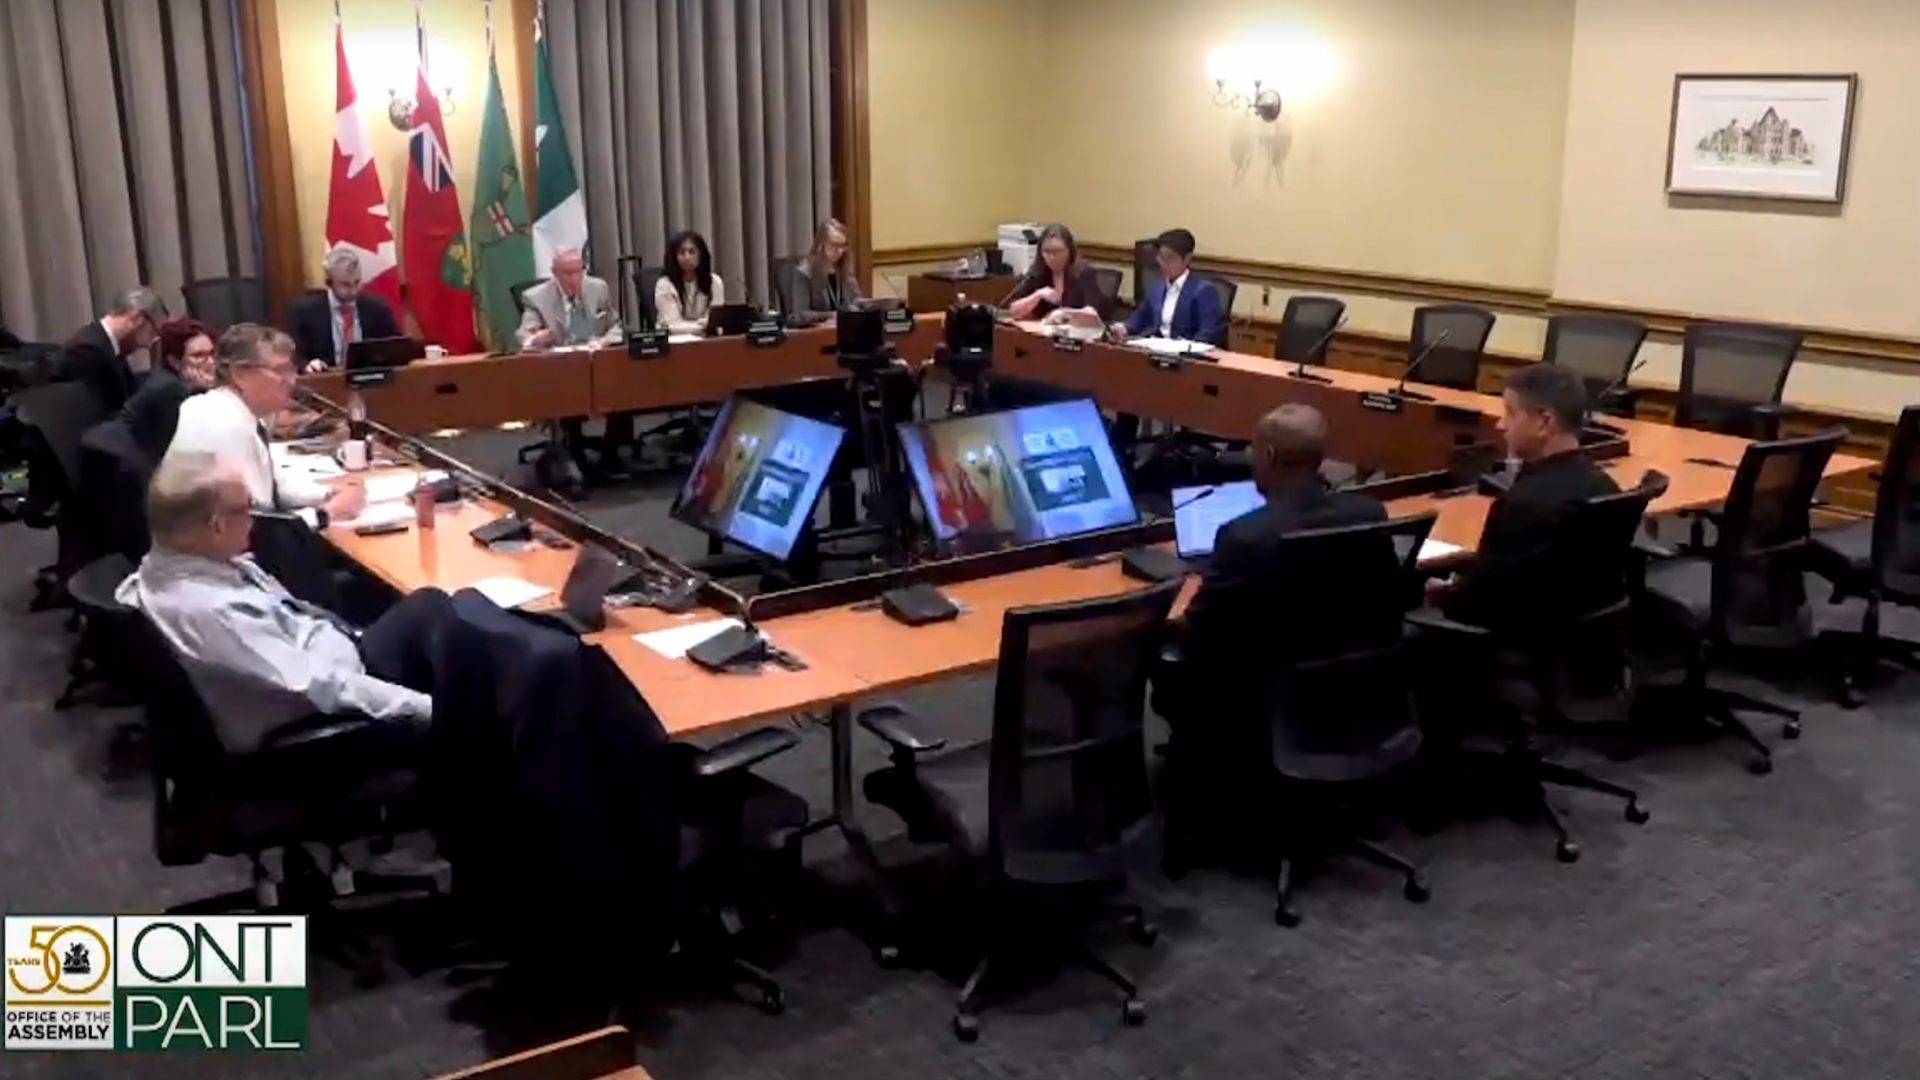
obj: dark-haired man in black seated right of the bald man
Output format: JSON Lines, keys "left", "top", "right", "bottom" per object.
{"left": 1428, "top": 363, "right": 1620, "bottom": 632}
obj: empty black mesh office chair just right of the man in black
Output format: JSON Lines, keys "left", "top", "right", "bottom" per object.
{"left": 1642, "top": 429, "right": 1845, "bottom": 774}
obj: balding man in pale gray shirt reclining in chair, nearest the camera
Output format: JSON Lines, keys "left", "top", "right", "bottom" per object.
{"left": 117, "top": 454, "right": 447, "bottom": 753}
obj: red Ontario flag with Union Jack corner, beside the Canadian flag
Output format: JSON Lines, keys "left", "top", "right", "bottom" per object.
{"left": 401, "top": 14, "right": 480, "bottom": 354}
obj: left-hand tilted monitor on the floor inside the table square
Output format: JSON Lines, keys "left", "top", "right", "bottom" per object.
{"left": 672, "top": 394, "right": 847, "bottom": 561}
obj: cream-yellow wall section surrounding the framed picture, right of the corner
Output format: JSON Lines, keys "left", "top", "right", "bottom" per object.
{"left": 1555, "top": 0, "right": 1920, "bottom": 336}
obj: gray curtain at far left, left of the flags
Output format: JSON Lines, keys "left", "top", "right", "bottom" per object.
{"left": 0, "top": 0, "right": 257, "bottom": 340}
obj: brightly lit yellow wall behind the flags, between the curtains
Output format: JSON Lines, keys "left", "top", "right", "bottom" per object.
{"left": 278, "top": 0, "right": 526, "bottom": 284}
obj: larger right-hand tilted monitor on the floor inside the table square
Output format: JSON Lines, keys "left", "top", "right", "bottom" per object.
{"left": 899, "top": 398, "right": 1140, "bottom": 552}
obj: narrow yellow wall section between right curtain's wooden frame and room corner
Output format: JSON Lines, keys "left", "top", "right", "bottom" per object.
{"left": 866, "top": 0, "right": 1054, "bottom": 248}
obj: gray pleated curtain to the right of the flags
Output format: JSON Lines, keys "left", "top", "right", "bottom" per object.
{"left": 541, "top": 0, "right": 833, "bottom": 304}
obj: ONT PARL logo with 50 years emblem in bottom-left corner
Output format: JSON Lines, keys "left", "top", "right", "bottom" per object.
{"left": 4, "top": 915, "right": 307, "bottom": 1053}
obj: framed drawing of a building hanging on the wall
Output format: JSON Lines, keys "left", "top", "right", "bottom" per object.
{"left": 1667, "top": 75, "right": 1859, "bottom": 202}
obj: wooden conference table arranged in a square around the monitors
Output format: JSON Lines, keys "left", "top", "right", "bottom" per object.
{"left": 303, "top": 317, "right": 1876, "bottom": 922}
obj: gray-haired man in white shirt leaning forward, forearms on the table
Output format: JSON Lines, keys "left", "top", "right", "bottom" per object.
{"left": 161, "top": 323, "right": 367, "bottom": 521}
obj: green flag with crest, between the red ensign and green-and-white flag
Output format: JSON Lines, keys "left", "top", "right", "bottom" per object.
{"left": 467, "top": 54, "right": 534, "bottom": 352}
